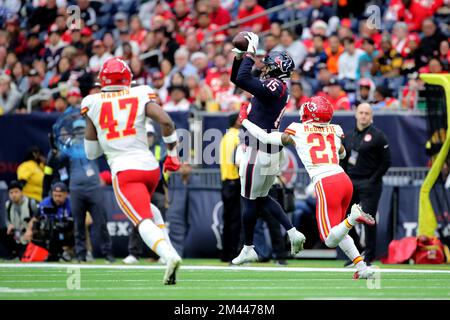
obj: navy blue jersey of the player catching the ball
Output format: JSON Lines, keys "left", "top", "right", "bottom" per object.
{"left": 230, "top": 57, "right": 289, "bottom": 149}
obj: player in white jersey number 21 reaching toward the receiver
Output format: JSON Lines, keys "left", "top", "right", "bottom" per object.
{"left": 240, "top": 96, "right": 375, "bottom": 279}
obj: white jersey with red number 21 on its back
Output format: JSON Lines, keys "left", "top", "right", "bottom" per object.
{"left": 284, "top": 122, "right": 344, "bottom": 184}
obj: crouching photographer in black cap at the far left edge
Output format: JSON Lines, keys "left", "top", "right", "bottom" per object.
{"left": 0, "top": 180, "right": 38, "bottom": 260}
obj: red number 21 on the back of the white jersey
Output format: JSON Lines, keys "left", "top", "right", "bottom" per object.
{"left": 306, "top": 133, "right": 339, "bottom": 164}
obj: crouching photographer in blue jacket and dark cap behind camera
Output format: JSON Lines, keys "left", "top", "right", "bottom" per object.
{"left": 32, "top": 182, "right": 75, "bottom": 261}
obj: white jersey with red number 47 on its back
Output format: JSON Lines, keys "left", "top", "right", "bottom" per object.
{"left": 81, "top": 85, "right": 159, "bottom": 176}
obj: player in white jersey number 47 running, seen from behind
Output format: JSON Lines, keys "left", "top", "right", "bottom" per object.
{"left": 81, "top": 58, "right": 181, "bottom": 285}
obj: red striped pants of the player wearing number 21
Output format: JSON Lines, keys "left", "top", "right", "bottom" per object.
{"left": 315, "top": 172, "right": 353, "bottom": 241}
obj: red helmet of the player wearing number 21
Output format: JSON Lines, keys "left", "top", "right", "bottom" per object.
{"left": 300, "top": 96, "right": 334, "bottom": 124}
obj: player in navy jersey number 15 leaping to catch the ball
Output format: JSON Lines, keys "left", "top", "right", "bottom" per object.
{"left": 231, "top": 32, "right": 305, "bottom": 265}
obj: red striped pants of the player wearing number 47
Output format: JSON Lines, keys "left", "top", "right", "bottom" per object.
{"left": 113, "top": 168, "right": 160, "bottom": 226}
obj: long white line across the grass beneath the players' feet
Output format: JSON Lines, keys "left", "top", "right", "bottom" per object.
{"left": 0, "top": 263, "right": 450, "bottom": 274}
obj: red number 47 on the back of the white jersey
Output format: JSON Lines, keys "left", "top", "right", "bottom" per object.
{"left": 99, "top": 97, "right": 139, "bottom": 140}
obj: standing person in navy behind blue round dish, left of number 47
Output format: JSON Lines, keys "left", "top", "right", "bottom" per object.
{"left": 44, "top": 110, "right": 115, "bottom": 263}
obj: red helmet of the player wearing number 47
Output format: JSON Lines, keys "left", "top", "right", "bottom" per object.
{"left": 98, "top": 57, "right": 133, "bottom": 88}
